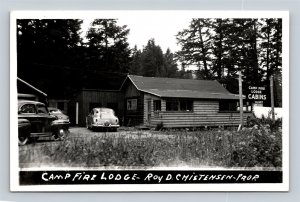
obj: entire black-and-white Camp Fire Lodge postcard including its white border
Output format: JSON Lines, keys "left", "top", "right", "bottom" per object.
{"left": 10, "top": 10, "right": 289, "bottom": 192}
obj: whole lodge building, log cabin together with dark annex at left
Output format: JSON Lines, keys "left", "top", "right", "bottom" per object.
{"left": 68, "top": 75, "right": 252, "bottom": 128}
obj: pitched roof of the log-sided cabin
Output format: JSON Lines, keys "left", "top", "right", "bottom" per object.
{"left": 126, "top": 75, "right": 239, "bottom": 99}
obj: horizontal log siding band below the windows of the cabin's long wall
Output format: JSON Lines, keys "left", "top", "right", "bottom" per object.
{"left": 151, "top": 112, "right": 252, "bottom": 128}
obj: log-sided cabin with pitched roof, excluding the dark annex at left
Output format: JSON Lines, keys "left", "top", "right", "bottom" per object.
{"left": 121, "top": 75, "right": 252, "bottom": 128}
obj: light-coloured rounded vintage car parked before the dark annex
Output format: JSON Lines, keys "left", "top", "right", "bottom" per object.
{"left": 86, "top": 108, "right": 120, "bottom": 131}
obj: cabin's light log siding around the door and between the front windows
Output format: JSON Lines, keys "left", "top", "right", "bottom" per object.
{"left": 144, "top": 96, "right": 252, "bottom": 128}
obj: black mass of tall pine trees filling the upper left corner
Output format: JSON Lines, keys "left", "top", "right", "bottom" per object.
{"left": 17, "top": 19, "right": 82, "bottom": 96}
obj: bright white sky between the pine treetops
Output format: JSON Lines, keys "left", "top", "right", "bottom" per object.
{"left": 82, "top": 15, "right": 191, "bottom": 53}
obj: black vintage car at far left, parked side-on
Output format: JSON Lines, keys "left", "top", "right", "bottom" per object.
{"left": 18, "top": 100, "right": 70, "bottom": 145}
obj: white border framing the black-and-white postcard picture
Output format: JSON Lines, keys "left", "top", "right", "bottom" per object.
{"left": 10, "top": 10, "right": 289, "bottom": 192}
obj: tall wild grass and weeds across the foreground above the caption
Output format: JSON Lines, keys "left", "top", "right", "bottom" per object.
{"left": 19, "top": 129, "right": 282, "bottom": 168}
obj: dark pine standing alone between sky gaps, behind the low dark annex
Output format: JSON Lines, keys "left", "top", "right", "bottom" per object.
{"left": 86, "top": 19, "right": 130, "bottom": 72}
